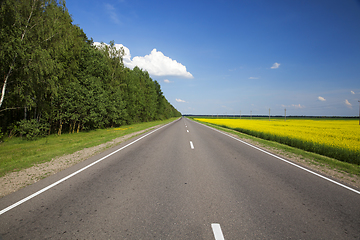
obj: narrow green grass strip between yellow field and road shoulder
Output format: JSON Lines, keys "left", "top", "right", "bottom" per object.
{"left": 192, "top": 119, "right": 360, "bottom": 176}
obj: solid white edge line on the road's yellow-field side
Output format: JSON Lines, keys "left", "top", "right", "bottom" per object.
{"left": 194, "top": 121, "right": 360, "bottom": 194}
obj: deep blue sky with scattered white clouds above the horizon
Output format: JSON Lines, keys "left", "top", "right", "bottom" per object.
{"left": 66, "top": 0, "right": 360, "bottom": 116}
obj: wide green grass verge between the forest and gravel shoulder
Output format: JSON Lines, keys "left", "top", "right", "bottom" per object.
{"left": 0, "top": 118, "right": 175, "bottom": 177}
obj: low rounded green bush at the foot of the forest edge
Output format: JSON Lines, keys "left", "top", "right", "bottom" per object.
{"left": 16, "top": 119, "right": 50, "bottom": 140}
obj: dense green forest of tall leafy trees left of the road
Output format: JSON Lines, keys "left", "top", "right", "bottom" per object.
{"left": 0, "top": 0, "right": 181, "bottom": 139}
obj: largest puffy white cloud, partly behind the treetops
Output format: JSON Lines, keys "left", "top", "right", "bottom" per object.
{"left": 94, "top": 42, "right": 193, "bottom": 78}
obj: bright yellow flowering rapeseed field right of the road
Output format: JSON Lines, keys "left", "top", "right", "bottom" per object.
{"left": 196, "top": 118, "right": 360, "bottom": 164}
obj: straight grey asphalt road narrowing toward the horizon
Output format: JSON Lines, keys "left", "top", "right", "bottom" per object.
{"left": 0, "top": 118, "right": 360, "bottom": 240}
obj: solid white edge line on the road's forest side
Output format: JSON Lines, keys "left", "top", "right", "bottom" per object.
{"left": 0, "top": 120, "right": 180, "bottom": 215}
